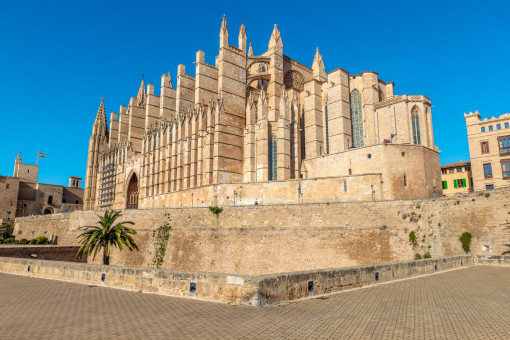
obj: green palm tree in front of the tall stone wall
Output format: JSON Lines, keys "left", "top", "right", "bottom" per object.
{"left": 76, "top": 210, "right": 138, "bottom": 265}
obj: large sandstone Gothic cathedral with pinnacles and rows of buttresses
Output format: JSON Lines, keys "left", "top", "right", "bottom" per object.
{"left": 84, "top": 17, "right": 442, "bottom": 209}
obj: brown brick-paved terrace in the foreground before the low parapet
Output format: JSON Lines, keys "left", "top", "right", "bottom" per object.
{"left": 0, "top": 266, "right": 510, "bottom": 339}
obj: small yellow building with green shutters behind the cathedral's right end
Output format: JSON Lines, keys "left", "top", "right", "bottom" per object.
{"left": 441, "top": 161, "right": 474, "bottom": 195}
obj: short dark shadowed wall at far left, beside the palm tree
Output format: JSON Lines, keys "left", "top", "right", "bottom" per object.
{"left": 0, "top": 244, "right": 87, "bottom": 263}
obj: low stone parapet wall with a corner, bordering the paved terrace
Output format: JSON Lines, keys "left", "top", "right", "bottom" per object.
{"left": 0, "top": 255, "right": 510, "bottom": 306}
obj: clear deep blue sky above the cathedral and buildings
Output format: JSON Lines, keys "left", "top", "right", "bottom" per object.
{"left": 0, "top": 0, "right": 510, "bottom": 185}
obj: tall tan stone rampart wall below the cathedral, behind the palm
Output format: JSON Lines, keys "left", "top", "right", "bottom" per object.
{"left": 10, "top": 190, "right": 510, "bottom": 275}
